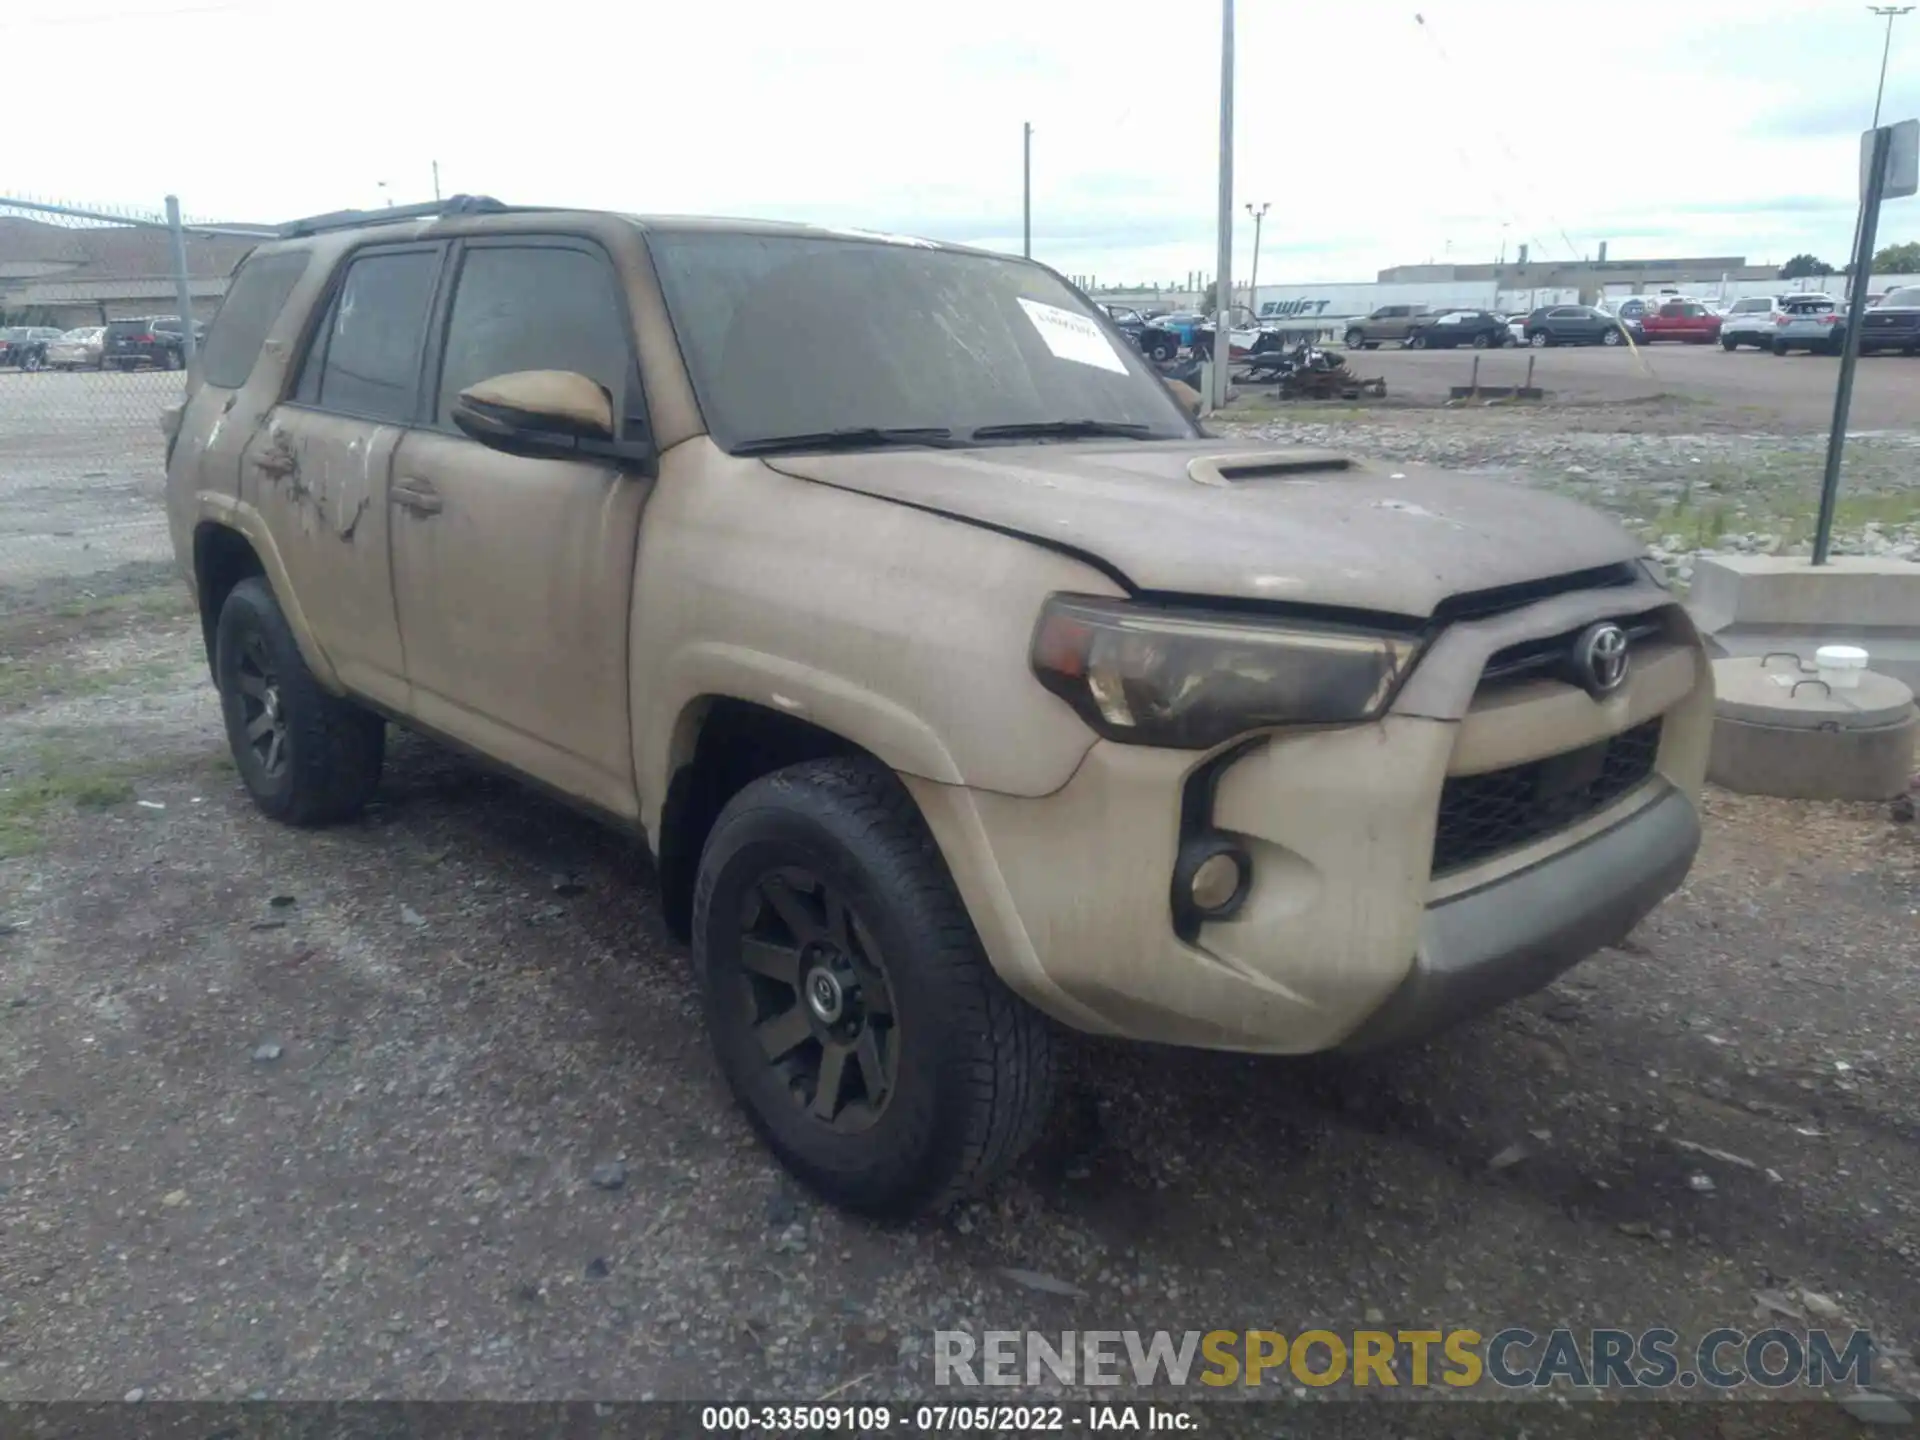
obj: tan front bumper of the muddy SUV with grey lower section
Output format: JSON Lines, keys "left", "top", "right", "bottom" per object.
{"left": 906, "top": 586, "right": 1713, "bottom": 1054}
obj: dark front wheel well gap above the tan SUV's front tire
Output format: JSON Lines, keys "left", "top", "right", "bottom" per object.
{"left": 655, "top": 697, "right": 876, "bottom": 941}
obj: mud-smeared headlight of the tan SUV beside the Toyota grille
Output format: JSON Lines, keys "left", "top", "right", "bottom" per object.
{"left": 1033, "top": 595, "right": 1419, "bottom": 751}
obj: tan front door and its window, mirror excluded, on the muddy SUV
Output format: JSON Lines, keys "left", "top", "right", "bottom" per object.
{"left": 392, "top": 236, "right": 649, "bottom": 816}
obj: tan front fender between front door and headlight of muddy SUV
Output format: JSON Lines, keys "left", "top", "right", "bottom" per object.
{"left": 630, "top": 445, "right": 1119, "bottom": 839}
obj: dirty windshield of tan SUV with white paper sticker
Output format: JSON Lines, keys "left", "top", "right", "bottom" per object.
{"left": 649, "top": 232, "right": 1194, "bottom": 449}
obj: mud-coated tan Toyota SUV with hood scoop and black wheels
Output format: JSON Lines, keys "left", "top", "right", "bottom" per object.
{"left": 165, "top": 198, "right": 1711, "bottom": 1213}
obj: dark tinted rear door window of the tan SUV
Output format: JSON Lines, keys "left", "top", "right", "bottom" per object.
{"left": 296, "top": 250, "right": 440, "bottom": 424}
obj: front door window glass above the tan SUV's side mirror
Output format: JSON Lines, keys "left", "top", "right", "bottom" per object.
{"left": 436, "top": 246, "right": 632, "bottom": 428}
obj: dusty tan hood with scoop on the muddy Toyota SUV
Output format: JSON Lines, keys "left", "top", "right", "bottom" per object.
{"left": 768, "top": 440, "right": 1642, "bottom": 618}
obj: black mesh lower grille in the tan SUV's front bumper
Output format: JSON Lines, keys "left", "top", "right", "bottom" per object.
{"left": 1434, "top": 720, "right": 1661, "bottom": 876}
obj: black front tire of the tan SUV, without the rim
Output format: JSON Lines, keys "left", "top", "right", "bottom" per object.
{"left": 693, "top": 758, "right": 1056, "bottom": 1217}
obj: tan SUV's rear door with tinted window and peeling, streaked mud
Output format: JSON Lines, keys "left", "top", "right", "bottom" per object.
{"left": 240, "top": 244, "right": 445, "bottom": 710}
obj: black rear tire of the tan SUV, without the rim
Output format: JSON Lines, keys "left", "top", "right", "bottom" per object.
{"left": 213, "top": 576, "right": 386, "bottom": 826}
